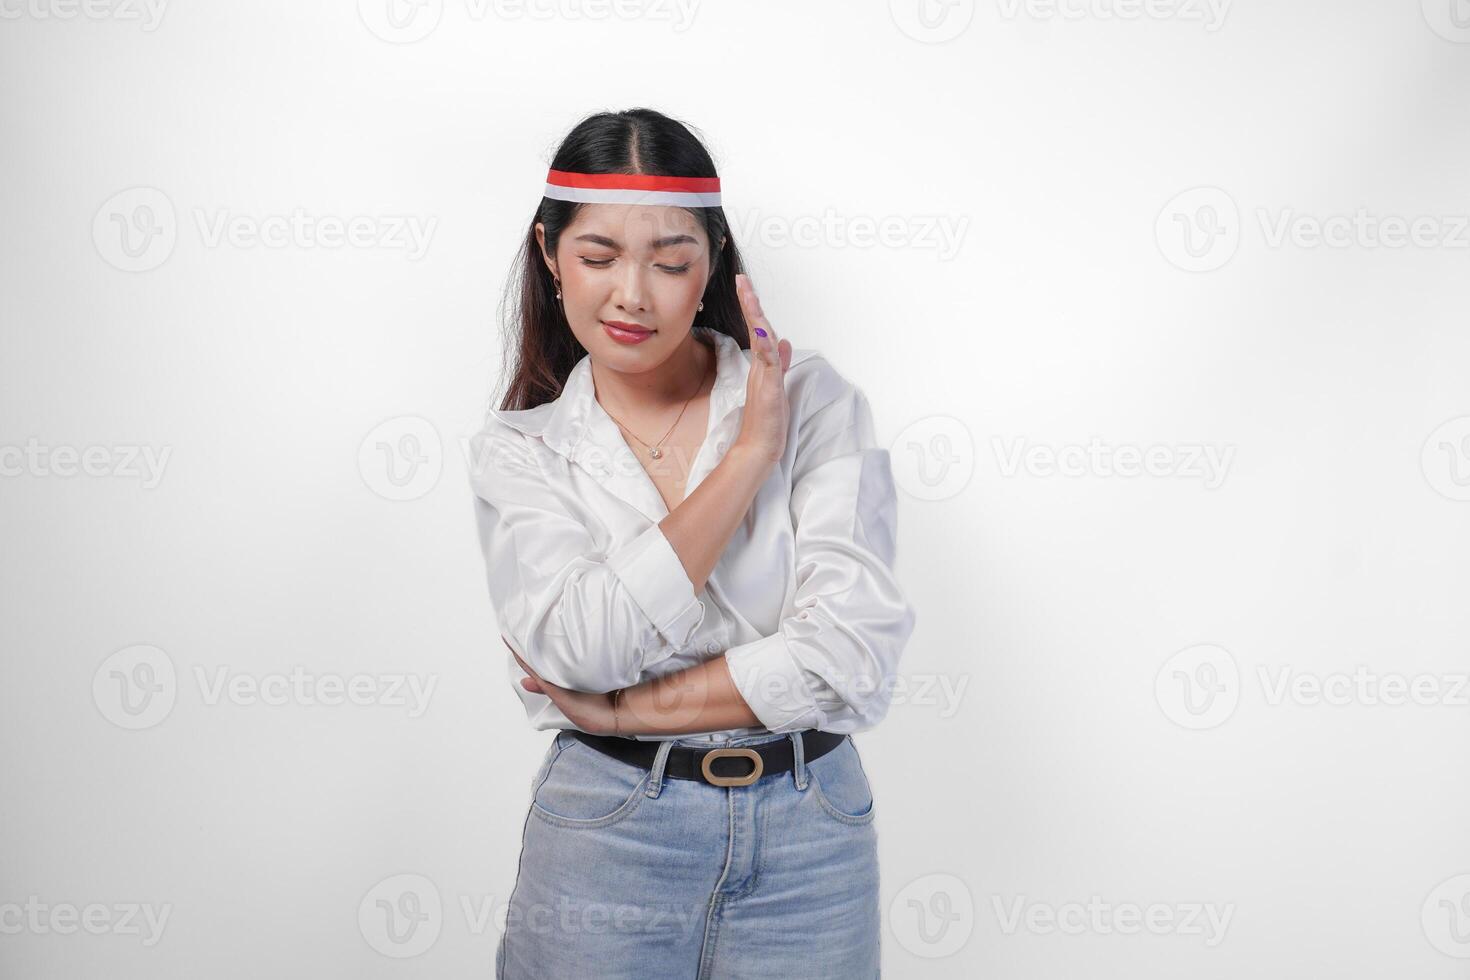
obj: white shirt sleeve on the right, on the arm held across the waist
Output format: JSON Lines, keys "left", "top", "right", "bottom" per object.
{"left": 725, "top": 385, "right": 917, "bottom": 733}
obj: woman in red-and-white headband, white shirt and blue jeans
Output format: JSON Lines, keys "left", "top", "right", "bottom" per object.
{"left": 472, "top": 110, "right": 914, "bottom": 980}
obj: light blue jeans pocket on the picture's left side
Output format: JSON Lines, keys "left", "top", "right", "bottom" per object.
{"left": 531, "top": 733, "right": 651, "bottom": 827}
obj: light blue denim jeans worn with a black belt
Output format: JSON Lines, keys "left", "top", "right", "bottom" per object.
{"left": 495, "top": 732, "right": 881, "bottom": 980}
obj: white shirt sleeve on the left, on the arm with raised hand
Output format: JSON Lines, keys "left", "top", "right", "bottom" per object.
{"left": 470, "top": 432, "right": 704, "bottom": 692}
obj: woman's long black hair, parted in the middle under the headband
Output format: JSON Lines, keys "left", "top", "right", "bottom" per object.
{"left": 500, "top": 109, "right": 750, "bottom": 411}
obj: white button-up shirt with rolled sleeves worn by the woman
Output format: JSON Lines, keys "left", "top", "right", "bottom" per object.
{"left": 470, "top": 328, "right": 916, "bottom": 742}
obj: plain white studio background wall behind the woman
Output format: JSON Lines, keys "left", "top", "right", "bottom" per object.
{"left": 0, "top": 0, "right": 1470, "bottom": 980}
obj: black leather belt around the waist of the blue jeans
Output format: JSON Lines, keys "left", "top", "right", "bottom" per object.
{"left": 567, "top": 729, "right": 847, "bottom": 786}
